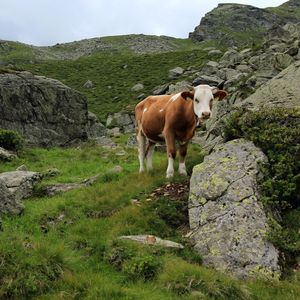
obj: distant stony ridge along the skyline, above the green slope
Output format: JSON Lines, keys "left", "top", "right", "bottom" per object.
{"left": 0, "top": 34, "right": 202, "bottom": 65}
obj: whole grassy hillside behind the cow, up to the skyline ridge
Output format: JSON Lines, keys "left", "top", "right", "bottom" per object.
{"left": 0, "top": 36, "right": 216, "bottom": 121}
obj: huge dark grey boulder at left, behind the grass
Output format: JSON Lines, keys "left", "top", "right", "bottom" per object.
{"left": 0, "top": 72, "right": 88, "bottom": 146}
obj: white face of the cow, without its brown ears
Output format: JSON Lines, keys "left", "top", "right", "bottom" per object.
{"left": 194, "top": 84, "right": 219, "bottom": 120}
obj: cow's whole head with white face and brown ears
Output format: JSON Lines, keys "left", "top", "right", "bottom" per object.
{"left": 181, "top": 84, "right": 227, "bottom": 121}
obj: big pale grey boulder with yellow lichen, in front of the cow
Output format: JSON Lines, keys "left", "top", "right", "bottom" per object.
{"left": 189, "top": 139, "right": 280, "bottom": 278}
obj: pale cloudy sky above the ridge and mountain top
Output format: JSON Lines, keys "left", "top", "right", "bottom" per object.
{"left": 0, "top": 0, "right": 286, "bottom": 46}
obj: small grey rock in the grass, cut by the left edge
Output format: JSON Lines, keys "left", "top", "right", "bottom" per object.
{"left": 0, "top": 171, "right": 42, "bottom": 214}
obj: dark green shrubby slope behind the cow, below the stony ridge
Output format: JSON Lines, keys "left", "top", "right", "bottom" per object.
{"left": 20, "top": 50, "right": 206, "bottom": 121}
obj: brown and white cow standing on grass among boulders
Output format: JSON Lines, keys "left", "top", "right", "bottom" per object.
{"left": 135, "top": 85, "right": 227, "bottom": 178}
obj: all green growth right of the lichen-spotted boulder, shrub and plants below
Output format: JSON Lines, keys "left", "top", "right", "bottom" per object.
{"left": 225, "top": 108, "right": 300, "bottom": 274}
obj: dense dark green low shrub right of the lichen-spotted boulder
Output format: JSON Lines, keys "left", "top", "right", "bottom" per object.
{"left": 224, "top": 107, "right": 300, "bottom": 211}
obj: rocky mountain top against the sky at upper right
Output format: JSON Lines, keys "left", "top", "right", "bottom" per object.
{"left": 189, "top": 0, "right": 300, "bottom": 46}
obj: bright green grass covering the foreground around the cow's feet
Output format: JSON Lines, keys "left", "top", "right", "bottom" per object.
{"left": 0, "top": 139, "right": 300, "bottom": 300}
